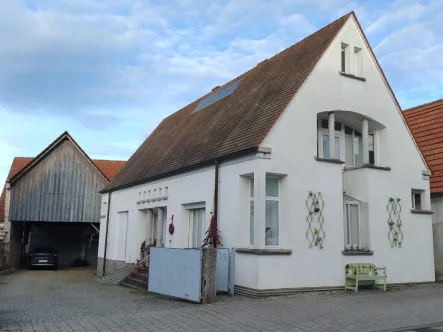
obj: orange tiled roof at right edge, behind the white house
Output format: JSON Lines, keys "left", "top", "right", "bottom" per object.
{"left": 403, "top": 99, "right": 443, "bottom": 193}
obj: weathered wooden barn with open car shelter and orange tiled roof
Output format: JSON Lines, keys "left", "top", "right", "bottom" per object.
{"left": 0, "top": 132, "right": 125, "bottom": 267}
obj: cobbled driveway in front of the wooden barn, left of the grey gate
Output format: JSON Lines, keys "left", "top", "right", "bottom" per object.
{"left": 0, "top": 269, "right": 189, "bottom": 328}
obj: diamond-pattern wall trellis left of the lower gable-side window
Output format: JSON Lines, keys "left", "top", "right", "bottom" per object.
{"left": 306, "top": 191, "right": 326, "bottom": 249}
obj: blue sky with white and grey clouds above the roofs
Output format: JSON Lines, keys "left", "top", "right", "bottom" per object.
{"left": 0, "top": 0, "right": 443, "bottom": 183}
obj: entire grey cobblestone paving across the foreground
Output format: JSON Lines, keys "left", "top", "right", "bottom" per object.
{"left": 0, "top": 270, "right": 443, "bottom": 332}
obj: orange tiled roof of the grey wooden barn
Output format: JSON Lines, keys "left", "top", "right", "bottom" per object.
{"left": 0, "top": 132, "right": 126, "bottom": 222}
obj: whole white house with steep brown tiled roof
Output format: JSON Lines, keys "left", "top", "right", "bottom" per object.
{"left": 99, "top": 13, "right": 435, "bottom": 294}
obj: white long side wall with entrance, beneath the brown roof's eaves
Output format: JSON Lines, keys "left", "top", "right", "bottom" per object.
{"left": 99, "top": 157, "right": 263, "bottom": 288}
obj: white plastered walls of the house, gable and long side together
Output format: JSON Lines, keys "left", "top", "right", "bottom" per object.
{"left": 99, "top": 18, "right": 434, "bottom": 289}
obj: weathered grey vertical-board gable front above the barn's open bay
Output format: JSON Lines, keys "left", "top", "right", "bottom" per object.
{"left": 10, "top": 140, "right": 106, "bottom": 222}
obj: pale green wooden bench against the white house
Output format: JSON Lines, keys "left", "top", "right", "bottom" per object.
{"left": 345, "top": 263, "right": 387, "bottom": 293}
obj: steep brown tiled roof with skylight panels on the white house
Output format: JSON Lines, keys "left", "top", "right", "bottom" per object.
{"left": 106, "top": 13, "right": 354, "bottom": 191}
